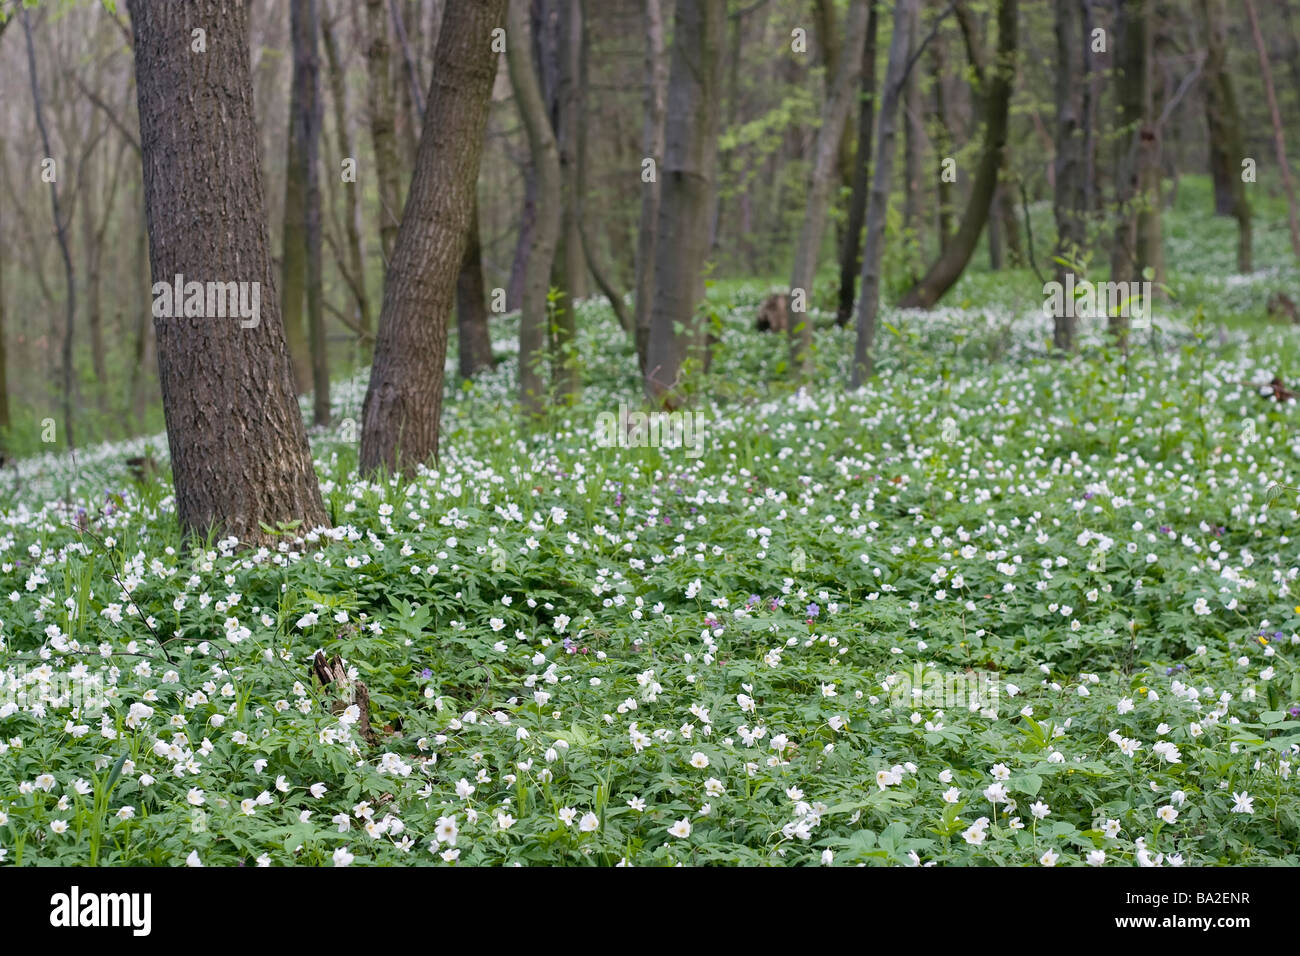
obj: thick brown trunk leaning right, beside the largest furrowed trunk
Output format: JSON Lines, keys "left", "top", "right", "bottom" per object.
{"left": 360, "top": 0, "right": 509, "bottom": 475}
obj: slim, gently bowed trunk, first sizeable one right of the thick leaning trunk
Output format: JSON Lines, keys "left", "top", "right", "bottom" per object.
{"left": 507, "top": 0, "right": 563, "bottom": 421}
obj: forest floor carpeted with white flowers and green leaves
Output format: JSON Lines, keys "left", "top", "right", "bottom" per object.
{"left": 0, "top": 174, "right": 1300, "bottom": 865}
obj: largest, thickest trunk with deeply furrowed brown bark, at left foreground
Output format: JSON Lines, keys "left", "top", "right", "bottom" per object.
{"left": 129, "top": 0, "right": 328, "bottom": 542}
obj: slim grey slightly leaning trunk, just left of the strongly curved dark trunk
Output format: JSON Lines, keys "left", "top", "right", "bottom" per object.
{"left": 852, "top": 0, "right": 918, "bottom": 389}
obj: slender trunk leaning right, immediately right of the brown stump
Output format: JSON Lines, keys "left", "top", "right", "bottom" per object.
{"left": 789, "top": 0, "right": 871, "bottom": 375}
